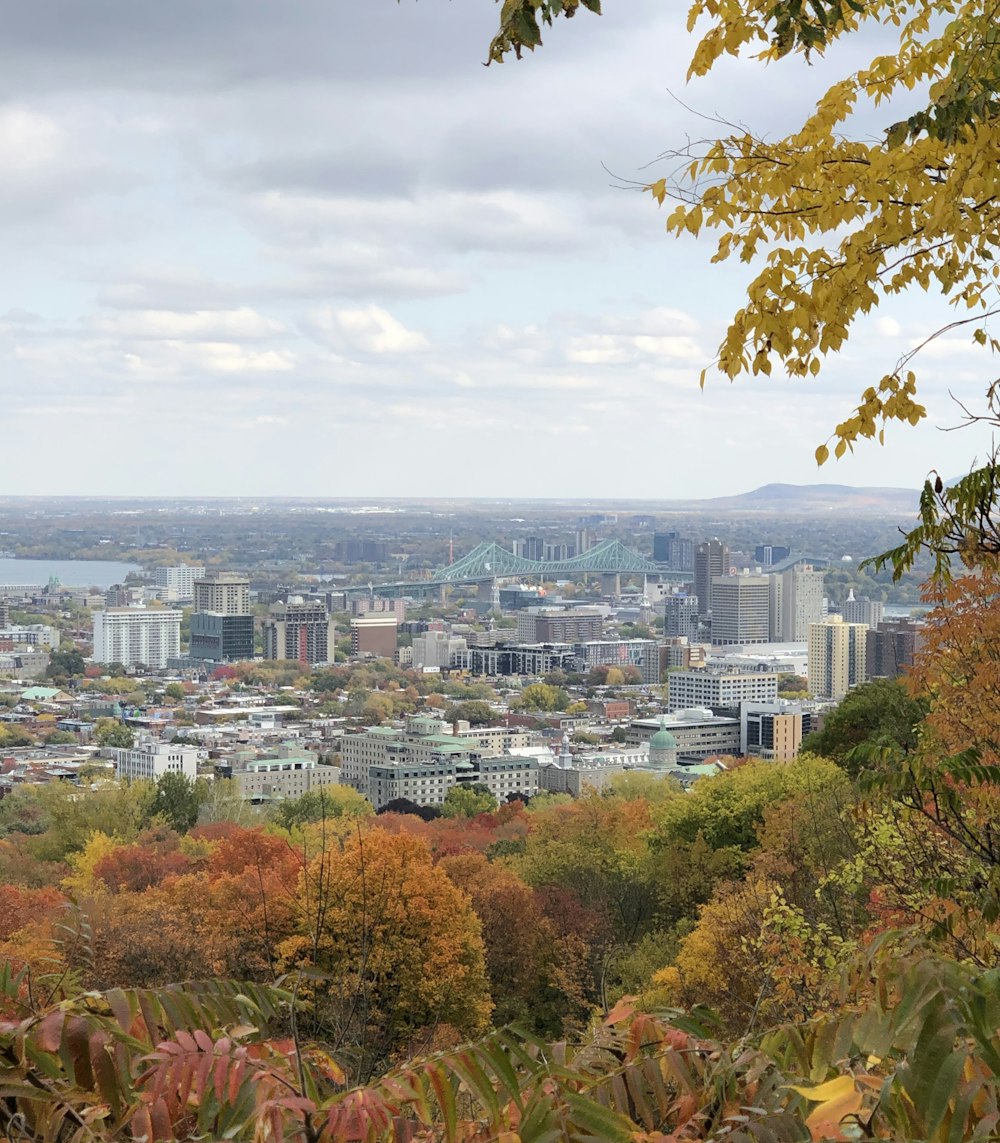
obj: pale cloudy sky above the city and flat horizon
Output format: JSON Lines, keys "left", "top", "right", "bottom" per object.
{"left": 0, "top": 0, "right": 992, "bottom": 498}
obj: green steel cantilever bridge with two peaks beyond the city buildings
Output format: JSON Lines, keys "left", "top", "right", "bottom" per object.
{"left": 350, "top": 539, "right": 690, "bottom": 596}
